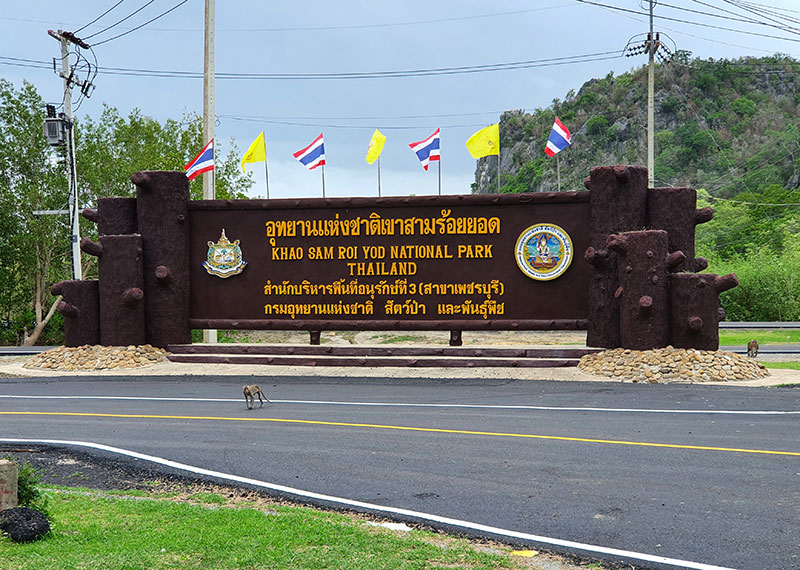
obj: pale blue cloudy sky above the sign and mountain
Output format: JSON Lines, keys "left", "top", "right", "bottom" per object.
{"left": 0, "top": 0, "right": 800, "bottom": 202}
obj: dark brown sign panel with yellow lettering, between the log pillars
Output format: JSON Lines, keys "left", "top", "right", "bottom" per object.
{"left": 189, "top": 192, "right": 589, "bottom": 330}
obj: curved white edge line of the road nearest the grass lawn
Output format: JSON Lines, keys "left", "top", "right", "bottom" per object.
{"left": 0, "top": 438, "right": 735, "bottom": 570}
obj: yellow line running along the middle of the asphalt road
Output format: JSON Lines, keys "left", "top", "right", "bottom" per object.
{"left": 0, "top": 412, "right": 800, "bottom": 457}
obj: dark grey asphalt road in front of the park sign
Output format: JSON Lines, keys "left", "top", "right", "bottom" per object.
{"left": 0, "top": 377, "right": 800, "bottom": 570}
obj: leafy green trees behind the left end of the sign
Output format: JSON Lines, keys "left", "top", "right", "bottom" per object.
{"left": 0, "top": 79, "right": 252, "bottom": 344}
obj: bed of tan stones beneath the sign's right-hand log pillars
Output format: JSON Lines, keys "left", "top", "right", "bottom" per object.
{"left": 578, "top": 346, "right": 769, "bottom": 383}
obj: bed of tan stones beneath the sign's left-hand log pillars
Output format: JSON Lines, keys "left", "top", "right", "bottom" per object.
{"left": 25, "top": 344, "right": 168, "bottom": 370}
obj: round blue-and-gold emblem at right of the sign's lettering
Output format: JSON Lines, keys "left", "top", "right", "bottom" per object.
{"left": 514, "top": 224, "right": 572, "bottom": 281}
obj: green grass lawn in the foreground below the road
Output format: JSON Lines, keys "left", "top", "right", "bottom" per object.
{"left": 0, "top": 489, "right": 535, "bottom": 570}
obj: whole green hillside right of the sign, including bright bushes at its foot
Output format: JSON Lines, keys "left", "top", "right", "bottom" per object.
{"left": 473, "top": 52, "right": 800, "bottom": 321}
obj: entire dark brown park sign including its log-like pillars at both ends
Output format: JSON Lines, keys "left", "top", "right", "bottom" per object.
{"left": 53, "top": 162, "right": 736, "bottom": 350}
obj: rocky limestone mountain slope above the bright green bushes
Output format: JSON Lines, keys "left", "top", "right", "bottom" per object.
{"left": 472, "top": 52, "right": 800, "bottom": 198}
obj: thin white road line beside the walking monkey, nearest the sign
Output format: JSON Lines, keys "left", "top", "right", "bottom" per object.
{"left": 0, "top": 394, "right": 800, "bottom": 416}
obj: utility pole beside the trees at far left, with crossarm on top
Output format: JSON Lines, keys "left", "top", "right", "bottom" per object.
{"left": 47, "top": 30, "right": 91, "bottom": 280}
